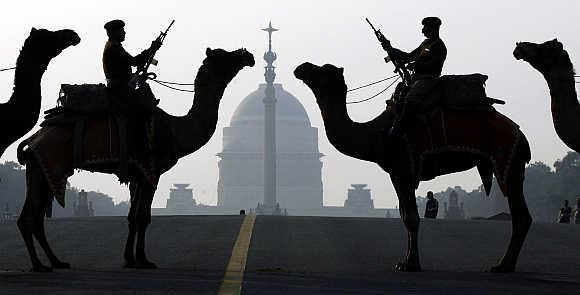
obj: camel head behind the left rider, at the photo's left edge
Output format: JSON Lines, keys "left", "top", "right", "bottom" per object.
{"left": 22, "top": 28, "right": 81, "bottom": 66}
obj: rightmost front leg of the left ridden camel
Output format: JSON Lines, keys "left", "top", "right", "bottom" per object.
{"left": 135, "top": 182, "right": 157, "bottom": 268}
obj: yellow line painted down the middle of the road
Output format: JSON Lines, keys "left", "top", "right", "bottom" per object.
{"left": 218, "top": 214, "right": 256, "bottom": 295}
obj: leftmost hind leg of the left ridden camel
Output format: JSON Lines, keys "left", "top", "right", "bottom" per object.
{"left": 17, "top": 160, "right": 52, "bottom": 272}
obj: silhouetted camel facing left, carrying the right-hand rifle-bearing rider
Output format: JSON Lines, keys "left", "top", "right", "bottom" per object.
{"left": 294, "top": 63, "right": 532, "bottom": 272}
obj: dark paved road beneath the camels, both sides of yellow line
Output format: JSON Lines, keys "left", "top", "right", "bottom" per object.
{"left": 0, "top": 216, "right": 580, "bottom": 295}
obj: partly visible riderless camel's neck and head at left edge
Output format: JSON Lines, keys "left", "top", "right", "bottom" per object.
{"left": 0, "top": 28, "right": 81, "bottom": 157}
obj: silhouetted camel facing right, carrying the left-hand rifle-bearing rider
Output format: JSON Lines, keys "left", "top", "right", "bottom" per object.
{"left": 17, "top": 48, "right": 255, "bottom": 272}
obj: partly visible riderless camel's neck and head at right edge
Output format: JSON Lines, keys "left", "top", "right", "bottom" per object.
{"left": 514, "top": 39, "right": 580, "bottom": 152}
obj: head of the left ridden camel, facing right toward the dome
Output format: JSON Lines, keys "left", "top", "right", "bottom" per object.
{"left": 195, "top": 48, "right": 256, "bottom": 85}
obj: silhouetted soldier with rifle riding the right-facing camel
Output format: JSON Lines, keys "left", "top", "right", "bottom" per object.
{"left": 103, "top": 19, "right": 161, "bottom": 182}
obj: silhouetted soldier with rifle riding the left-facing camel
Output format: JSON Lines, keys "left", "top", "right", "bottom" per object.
{"left": 382, "top": 16, "right": 447, "bottom": 135}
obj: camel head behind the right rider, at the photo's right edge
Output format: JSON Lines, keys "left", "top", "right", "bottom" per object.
{"left": 514, "top": 39, "right": 573, "bottom": 74}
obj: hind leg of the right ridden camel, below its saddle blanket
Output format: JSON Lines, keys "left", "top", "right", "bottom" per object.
{"left": 490, "top": 163, "right": 532, "bottom": 272}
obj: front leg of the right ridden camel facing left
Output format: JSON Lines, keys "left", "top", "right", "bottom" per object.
{"left": 391, "top": 176, "right": 421, "bottom": 271}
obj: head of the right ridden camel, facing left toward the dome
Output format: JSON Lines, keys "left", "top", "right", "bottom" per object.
{"left": 294, "top": 62, "right": 347, "bottom": 103}
